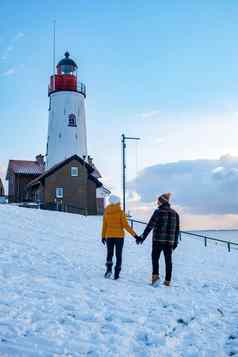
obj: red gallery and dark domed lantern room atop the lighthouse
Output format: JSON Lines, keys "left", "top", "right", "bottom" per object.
{"left": 48, "top": 52, "right": 86, "bottom": 97}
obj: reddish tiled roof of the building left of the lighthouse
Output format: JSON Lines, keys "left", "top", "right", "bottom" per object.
{"left": 7, "top": 160, "right": 44, "bottom": 179}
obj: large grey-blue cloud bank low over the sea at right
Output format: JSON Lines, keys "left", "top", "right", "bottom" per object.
{"left": 128, "top": 155, "right": 238, "bottom": 215}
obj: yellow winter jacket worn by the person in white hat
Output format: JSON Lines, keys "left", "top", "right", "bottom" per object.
{"left": 102, "top": 204, "right": 136, "bottom": 238}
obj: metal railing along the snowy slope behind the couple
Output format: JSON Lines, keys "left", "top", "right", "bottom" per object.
{"left": 128, "top": 218, "right": 238, "bottom": 252}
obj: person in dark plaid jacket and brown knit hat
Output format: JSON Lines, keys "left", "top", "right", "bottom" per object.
{"left": 136, "top": 193, "right": 179, "bottom": 286}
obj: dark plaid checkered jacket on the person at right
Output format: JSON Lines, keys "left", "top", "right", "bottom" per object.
{"left": 142, "top": 203, "right": 179, "bottom": 245}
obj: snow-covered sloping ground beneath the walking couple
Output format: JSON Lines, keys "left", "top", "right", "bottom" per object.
{"left": 0, "top": 205, "right": 238, "bottom": 357}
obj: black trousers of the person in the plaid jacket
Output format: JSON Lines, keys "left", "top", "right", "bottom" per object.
{"left": 151, "top": 242, "right": 173, "bottom": 281}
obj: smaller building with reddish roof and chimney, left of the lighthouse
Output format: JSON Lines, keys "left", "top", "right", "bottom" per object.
{"left": 6, "top": 155, "right": 44, "bottom": 203}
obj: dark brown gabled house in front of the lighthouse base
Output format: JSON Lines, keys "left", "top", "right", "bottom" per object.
{"left": 27, "top": 155, "right": 104, "bottom": 215}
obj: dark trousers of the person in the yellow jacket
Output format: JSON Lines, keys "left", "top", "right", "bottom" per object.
{"left": 106, "top": 238, "right": 124, "bottom": 273}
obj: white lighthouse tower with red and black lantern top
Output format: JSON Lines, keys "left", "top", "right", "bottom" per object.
{"left": 46, "top": 52, "right": 87, "bottom": 169}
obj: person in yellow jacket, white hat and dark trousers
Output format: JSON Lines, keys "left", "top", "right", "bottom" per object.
{"left": 102, "top": 195, "right": 137, "bottom": 280}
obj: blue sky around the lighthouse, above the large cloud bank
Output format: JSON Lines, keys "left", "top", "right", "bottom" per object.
{"left": 0, "top": 0, "right": 238, "bottom": 225}
